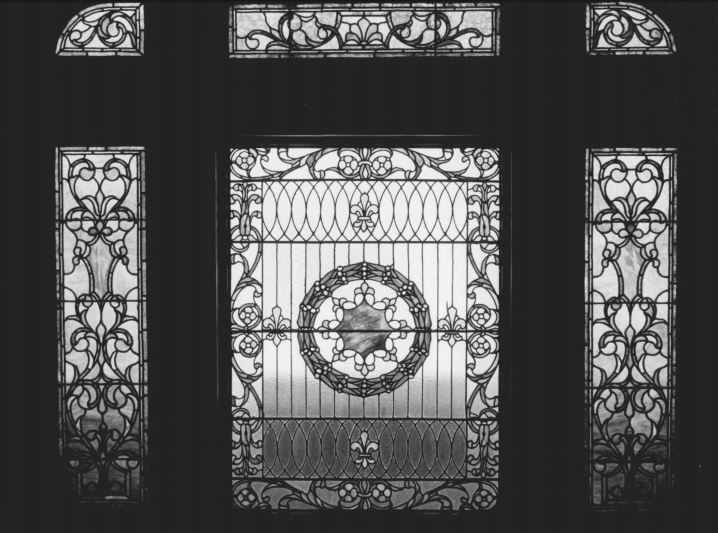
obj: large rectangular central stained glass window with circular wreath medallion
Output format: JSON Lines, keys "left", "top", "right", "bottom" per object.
{"left": 230, "top": 147, "right": 501, "bottom": 510}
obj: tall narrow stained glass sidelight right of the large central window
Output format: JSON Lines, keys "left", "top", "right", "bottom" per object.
{"left": 586, "top": 149, "right": 676, "bottom": 505}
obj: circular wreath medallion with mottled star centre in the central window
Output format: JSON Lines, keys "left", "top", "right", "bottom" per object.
{"left": 298, "top": 263, "right": 431, "bottom": 397}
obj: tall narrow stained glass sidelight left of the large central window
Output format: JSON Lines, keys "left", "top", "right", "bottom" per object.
{"left": 56, "top": 148, "right": 147, "bottom": 501}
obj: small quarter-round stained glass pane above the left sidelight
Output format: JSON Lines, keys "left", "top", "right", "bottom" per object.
{"left": 56, "top": 2, "right": 145, "bottom": 56}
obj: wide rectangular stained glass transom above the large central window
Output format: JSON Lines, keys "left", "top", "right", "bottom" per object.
{"left": 229, "top": 2, "right": 499, "bottom": 57}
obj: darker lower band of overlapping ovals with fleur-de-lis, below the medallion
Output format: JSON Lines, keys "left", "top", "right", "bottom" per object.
{"left": 263, "top": 419, "right": 467, "bottom": 479}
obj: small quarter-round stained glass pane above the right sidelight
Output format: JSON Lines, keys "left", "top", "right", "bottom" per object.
{"left": 586, "top": 2, "right": 676, "bottom": 55}
